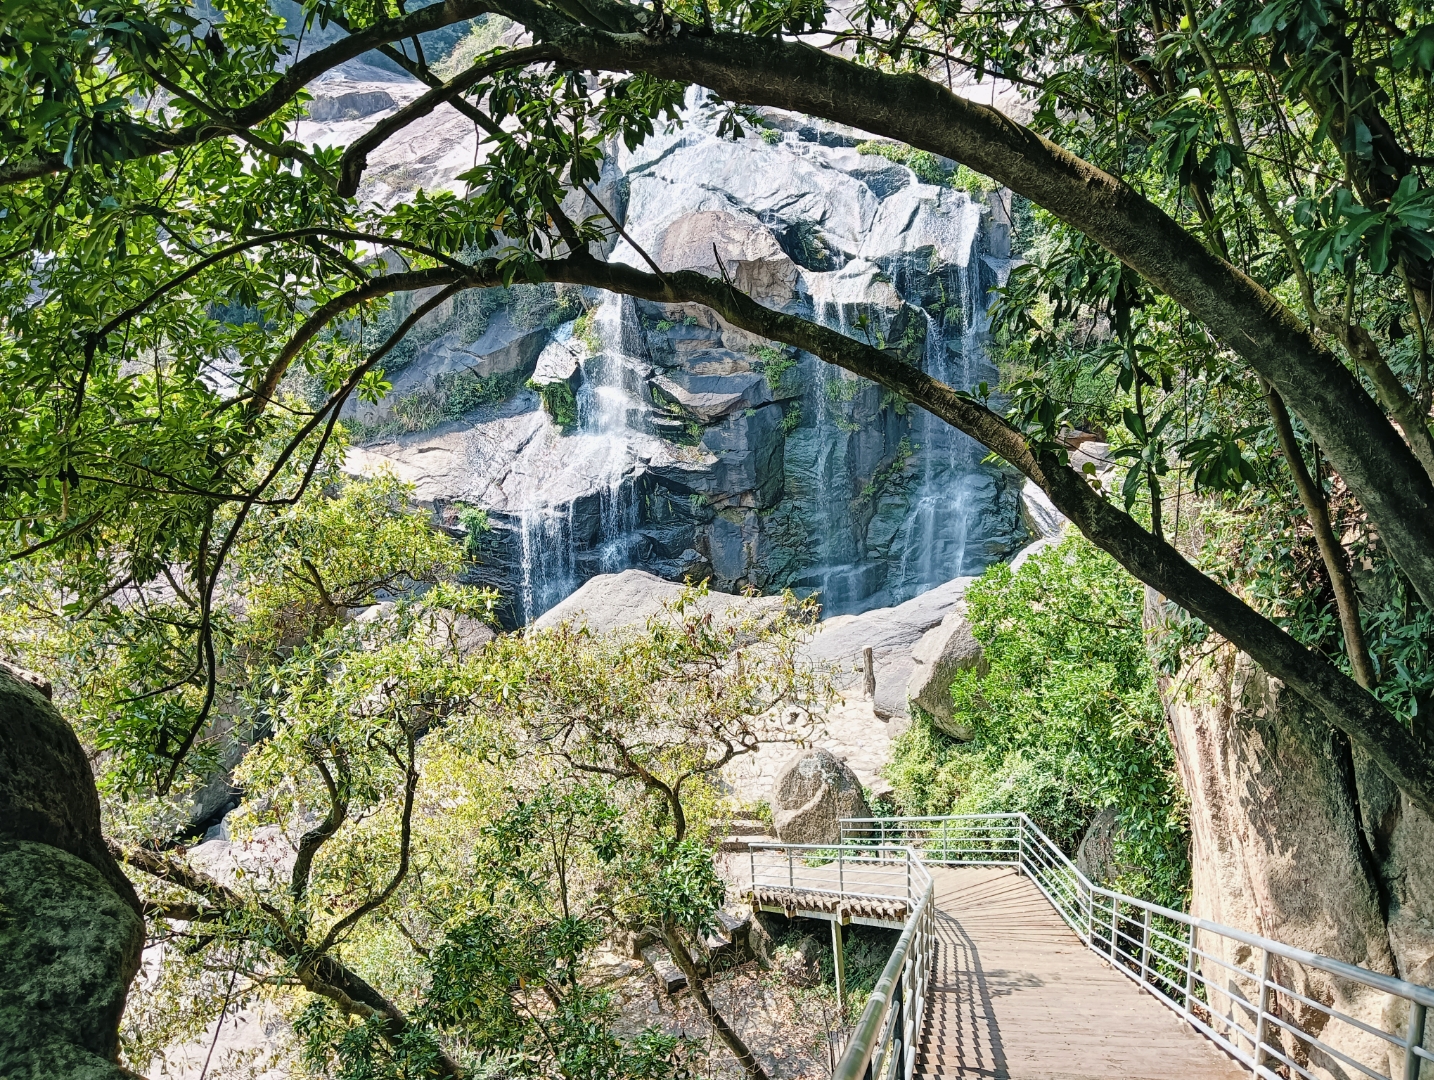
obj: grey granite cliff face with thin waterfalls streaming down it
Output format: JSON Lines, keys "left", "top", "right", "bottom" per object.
{"left": 332, "top": 85, "right": 1028, "bottom": 624}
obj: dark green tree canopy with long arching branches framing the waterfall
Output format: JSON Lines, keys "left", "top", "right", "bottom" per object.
{"left": 0, "top": 0, "right": 1434, "bottom": 807}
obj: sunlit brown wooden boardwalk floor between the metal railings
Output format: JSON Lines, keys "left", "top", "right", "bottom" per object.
{"left": 916, "top": 866, "right": 1248, "bottom": 1080}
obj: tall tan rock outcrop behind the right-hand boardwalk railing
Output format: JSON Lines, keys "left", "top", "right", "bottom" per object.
{"left": 1147, "top": 628, "right": 1434, "bottom": 1077}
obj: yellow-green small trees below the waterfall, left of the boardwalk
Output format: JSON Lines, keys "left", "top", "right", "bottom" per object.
{"left": 106, "top": 582, "right": 829, "bottom": 1080}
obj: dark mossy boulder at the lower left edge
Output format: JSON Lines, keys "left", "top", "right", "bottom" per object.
{"left": 0, "top": 665, "right": 145, "bottom": 1080}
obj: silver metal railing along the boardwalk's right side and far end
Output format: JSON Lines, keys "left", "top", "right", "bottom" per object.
{"left": 842, "top": 813, "right": 1434, "bottom": 1080}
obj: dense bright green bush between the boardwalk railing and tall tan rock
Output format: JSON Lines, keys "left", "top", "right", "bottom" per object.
{"left": 888, "top": 535, "right": 1189, "bottom": 906}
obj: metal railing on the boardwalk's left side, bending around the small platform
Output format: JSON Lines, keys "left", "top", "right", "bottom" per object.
{"left": 749, "top": 843, "right": 936, "bottom": 1080}
